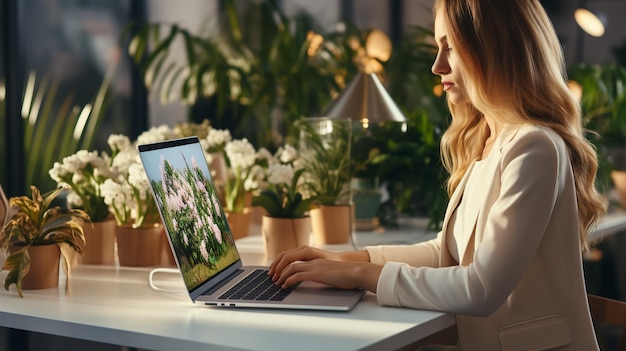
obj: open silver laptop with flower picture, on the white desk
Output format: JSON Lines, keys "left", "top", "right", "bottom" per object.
{"left": 137, "top": 137, "right": 365, "bottom": 311}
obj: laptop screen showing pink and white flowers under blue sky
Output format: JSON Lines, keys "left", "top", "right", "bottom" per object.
{"left": 138, "top": 137, "right": 239, "bottom": 292}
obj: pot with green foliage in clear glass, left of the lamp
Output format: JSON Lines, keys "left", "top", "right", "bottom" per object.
{"left": 297, "top": 117, "right": 352, "bottom": 244}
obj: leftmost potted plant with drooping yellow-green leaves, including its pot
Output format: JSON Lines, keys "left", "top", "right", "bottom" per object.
{"left": 0, "top": 186, "right": 90, "bottom": 297}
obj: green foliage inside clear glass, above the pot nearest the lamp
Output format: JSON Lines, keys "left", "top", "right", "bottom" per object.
{"left": 296, "top": 117, "right": 352, "bottom": 206}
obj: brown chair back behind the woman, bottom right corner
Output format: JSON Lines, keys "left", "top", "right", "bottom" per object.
{"left": 587, "top": 294, "right": 626, "bottom": 351}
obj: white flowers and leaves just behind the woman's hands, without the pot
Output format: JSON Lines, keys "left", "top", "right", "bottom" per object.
{"left": 252, "top": 144, "right": 315, "bottom": 218}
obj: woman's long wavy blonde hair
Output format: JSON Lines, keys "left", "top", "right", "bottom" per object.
{"left": 434, "top": 0, "right": 606, "bottom": 249}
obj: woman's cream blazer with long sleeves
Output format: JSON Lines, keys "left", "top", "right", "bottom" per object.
{"left": 366, "top": 125, "right": 598, "bottom": 351}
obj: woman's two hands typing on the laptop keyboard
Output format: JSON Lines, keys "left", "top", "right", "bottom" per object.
{"left": 269, "top": 246, "right": 382, "bottom": 292}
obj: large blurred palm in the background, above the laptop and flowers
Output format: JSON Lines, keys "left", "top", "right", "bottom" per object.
{"left": 123, "top": 0, "right": 342, "bottom": 148}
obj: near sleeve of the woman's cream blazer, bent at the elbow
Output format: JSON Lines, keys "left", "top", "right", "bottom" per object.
{"left": 370, "top": 129, "right": 569, "bottom": 316}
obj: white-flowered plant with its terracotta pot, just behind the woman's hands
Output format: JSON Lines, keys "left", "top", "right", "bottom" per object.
{"left": 252, "top": 144, "right": 314, "bottom": 259}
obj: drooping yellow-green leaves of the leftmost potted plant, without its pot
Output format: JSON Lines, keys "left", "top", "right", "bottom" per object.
{"left": 0, "top": 186, "right": 90, "bottom": 297}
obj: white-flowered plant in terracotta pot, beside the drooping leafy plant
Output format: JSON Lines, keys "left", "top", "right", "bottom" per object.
{"left": 48, "top": 150, "right": 115, "bottom": 264}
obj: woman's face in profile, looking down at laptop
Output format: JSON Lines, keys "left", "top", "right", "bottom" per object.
{"left": 432, "top": 10, "right": 470, "bottom": 105}
